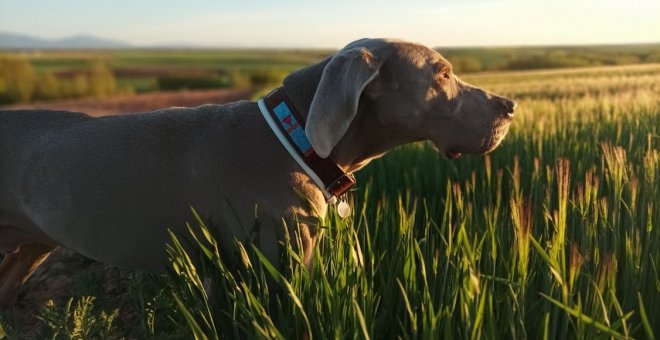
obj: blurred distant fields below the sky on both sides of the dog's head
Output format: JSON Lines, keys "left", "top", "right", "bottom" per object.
{"left": 0, "top": 44, "right": 660, "bottom": 104}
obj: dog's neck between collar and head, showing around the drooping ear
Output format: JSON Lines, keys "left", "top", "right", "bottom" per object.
{"left": 282, "top": 58, "right": 421, "bottom": 173}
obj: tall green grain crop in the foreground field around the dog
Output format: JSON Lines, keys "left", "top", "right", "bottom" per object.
{"left": 0, "top": 60, "right": 660, "bottom": 339}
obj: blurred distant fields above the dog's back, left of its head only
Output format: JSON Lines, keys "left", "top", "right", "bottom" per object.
{"left": 0, "top": 50, "right": 332, "bottom": 105}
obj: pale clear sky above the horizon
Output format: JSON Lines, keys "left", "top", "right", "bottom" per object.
{"left": 0, "top": 0, "right": 660, "bottom": 48}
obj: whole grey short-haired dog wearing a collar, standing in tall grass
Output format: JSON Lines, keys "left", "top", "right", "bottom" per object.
{"left": 0, "top": 39, "right": 516, "bottom": 306}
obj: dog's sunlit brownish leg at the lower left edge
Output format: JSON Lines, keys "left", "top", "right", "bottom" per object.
{"left": 0, "top": 243, "right": 55, "bottom": 307}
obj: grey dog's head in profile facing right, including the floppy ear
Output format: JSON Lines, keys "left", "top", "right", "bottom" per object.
{"left": 294, "top": 39, "right": 516, "bottom": 158}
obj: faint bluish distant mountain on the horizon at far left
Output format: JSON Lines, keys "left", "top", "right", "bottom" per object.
{"left": 0, "top": 32, "right": 132, "bottom": 50}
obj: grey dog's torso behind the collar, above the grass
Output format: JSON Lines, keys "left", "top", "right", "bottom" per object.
{"left": 0, "top": 102, "right": 314, "bottom": 270}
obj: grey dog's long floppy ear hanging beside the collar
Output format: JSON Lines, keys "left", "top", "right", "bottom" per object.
{"left": 305, "top": 47, "right": 383, "bottom": 158}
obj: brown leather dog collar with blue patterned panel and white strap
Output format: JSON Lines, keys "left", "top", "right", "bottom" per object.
{"left": 258, "top": 87, "right": 356, "bottom": 204}
